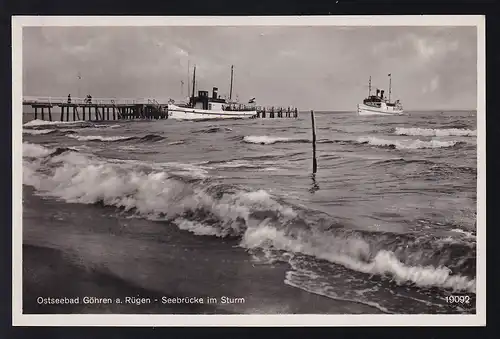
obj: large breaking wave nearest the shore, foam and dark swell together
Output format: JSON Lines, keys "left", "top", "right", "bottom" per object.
{"left": 23, "top": 143, "right": 476, "bottom": 293}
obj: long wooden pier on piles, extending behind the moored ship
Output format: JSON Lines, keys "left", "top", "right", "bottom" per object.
{"left": 23, "top": 97, "right": 299, "bottom": 121}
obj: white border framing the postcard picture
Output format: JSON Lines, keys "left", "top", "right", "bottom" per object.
{"left": 12, "top": 15, "right": 486, "bottom": 327}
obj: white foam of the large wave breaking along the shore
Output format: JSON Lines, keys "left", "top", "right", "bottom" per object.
{"left": 23, "top": 143, "right": 475, "bottom": 293}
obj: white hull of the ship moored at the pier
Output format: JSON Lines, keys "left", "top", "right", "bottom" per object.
{"left": 168, "top": 104, "right": 257, "bottom": 120}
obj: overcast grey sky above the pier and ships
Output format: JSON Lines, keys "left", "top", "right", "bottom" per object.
{"left": 23, "top": 26, "right": 477, "bottom": 110}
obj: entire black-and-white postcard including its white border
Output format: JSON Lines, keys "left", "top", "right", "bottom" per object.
{"left": 12, "top": 16, "right": 486, "bottom": 326}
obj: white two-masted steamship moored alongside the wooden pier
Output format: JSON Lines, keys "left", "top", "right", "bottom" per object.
{"left": 167, "top": 66, "right": 257, "bottom": 120}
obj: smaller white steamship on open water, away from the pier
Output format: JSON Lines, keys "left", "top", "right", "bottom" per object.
{"left": 358, "top": 74, "right": 404, "bottom": 115}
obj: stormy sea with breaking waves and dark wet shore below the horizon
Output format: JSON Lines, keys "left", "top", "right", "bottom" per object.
{"left": 22, "top": 111, "right": 477, "bottom": 314}
